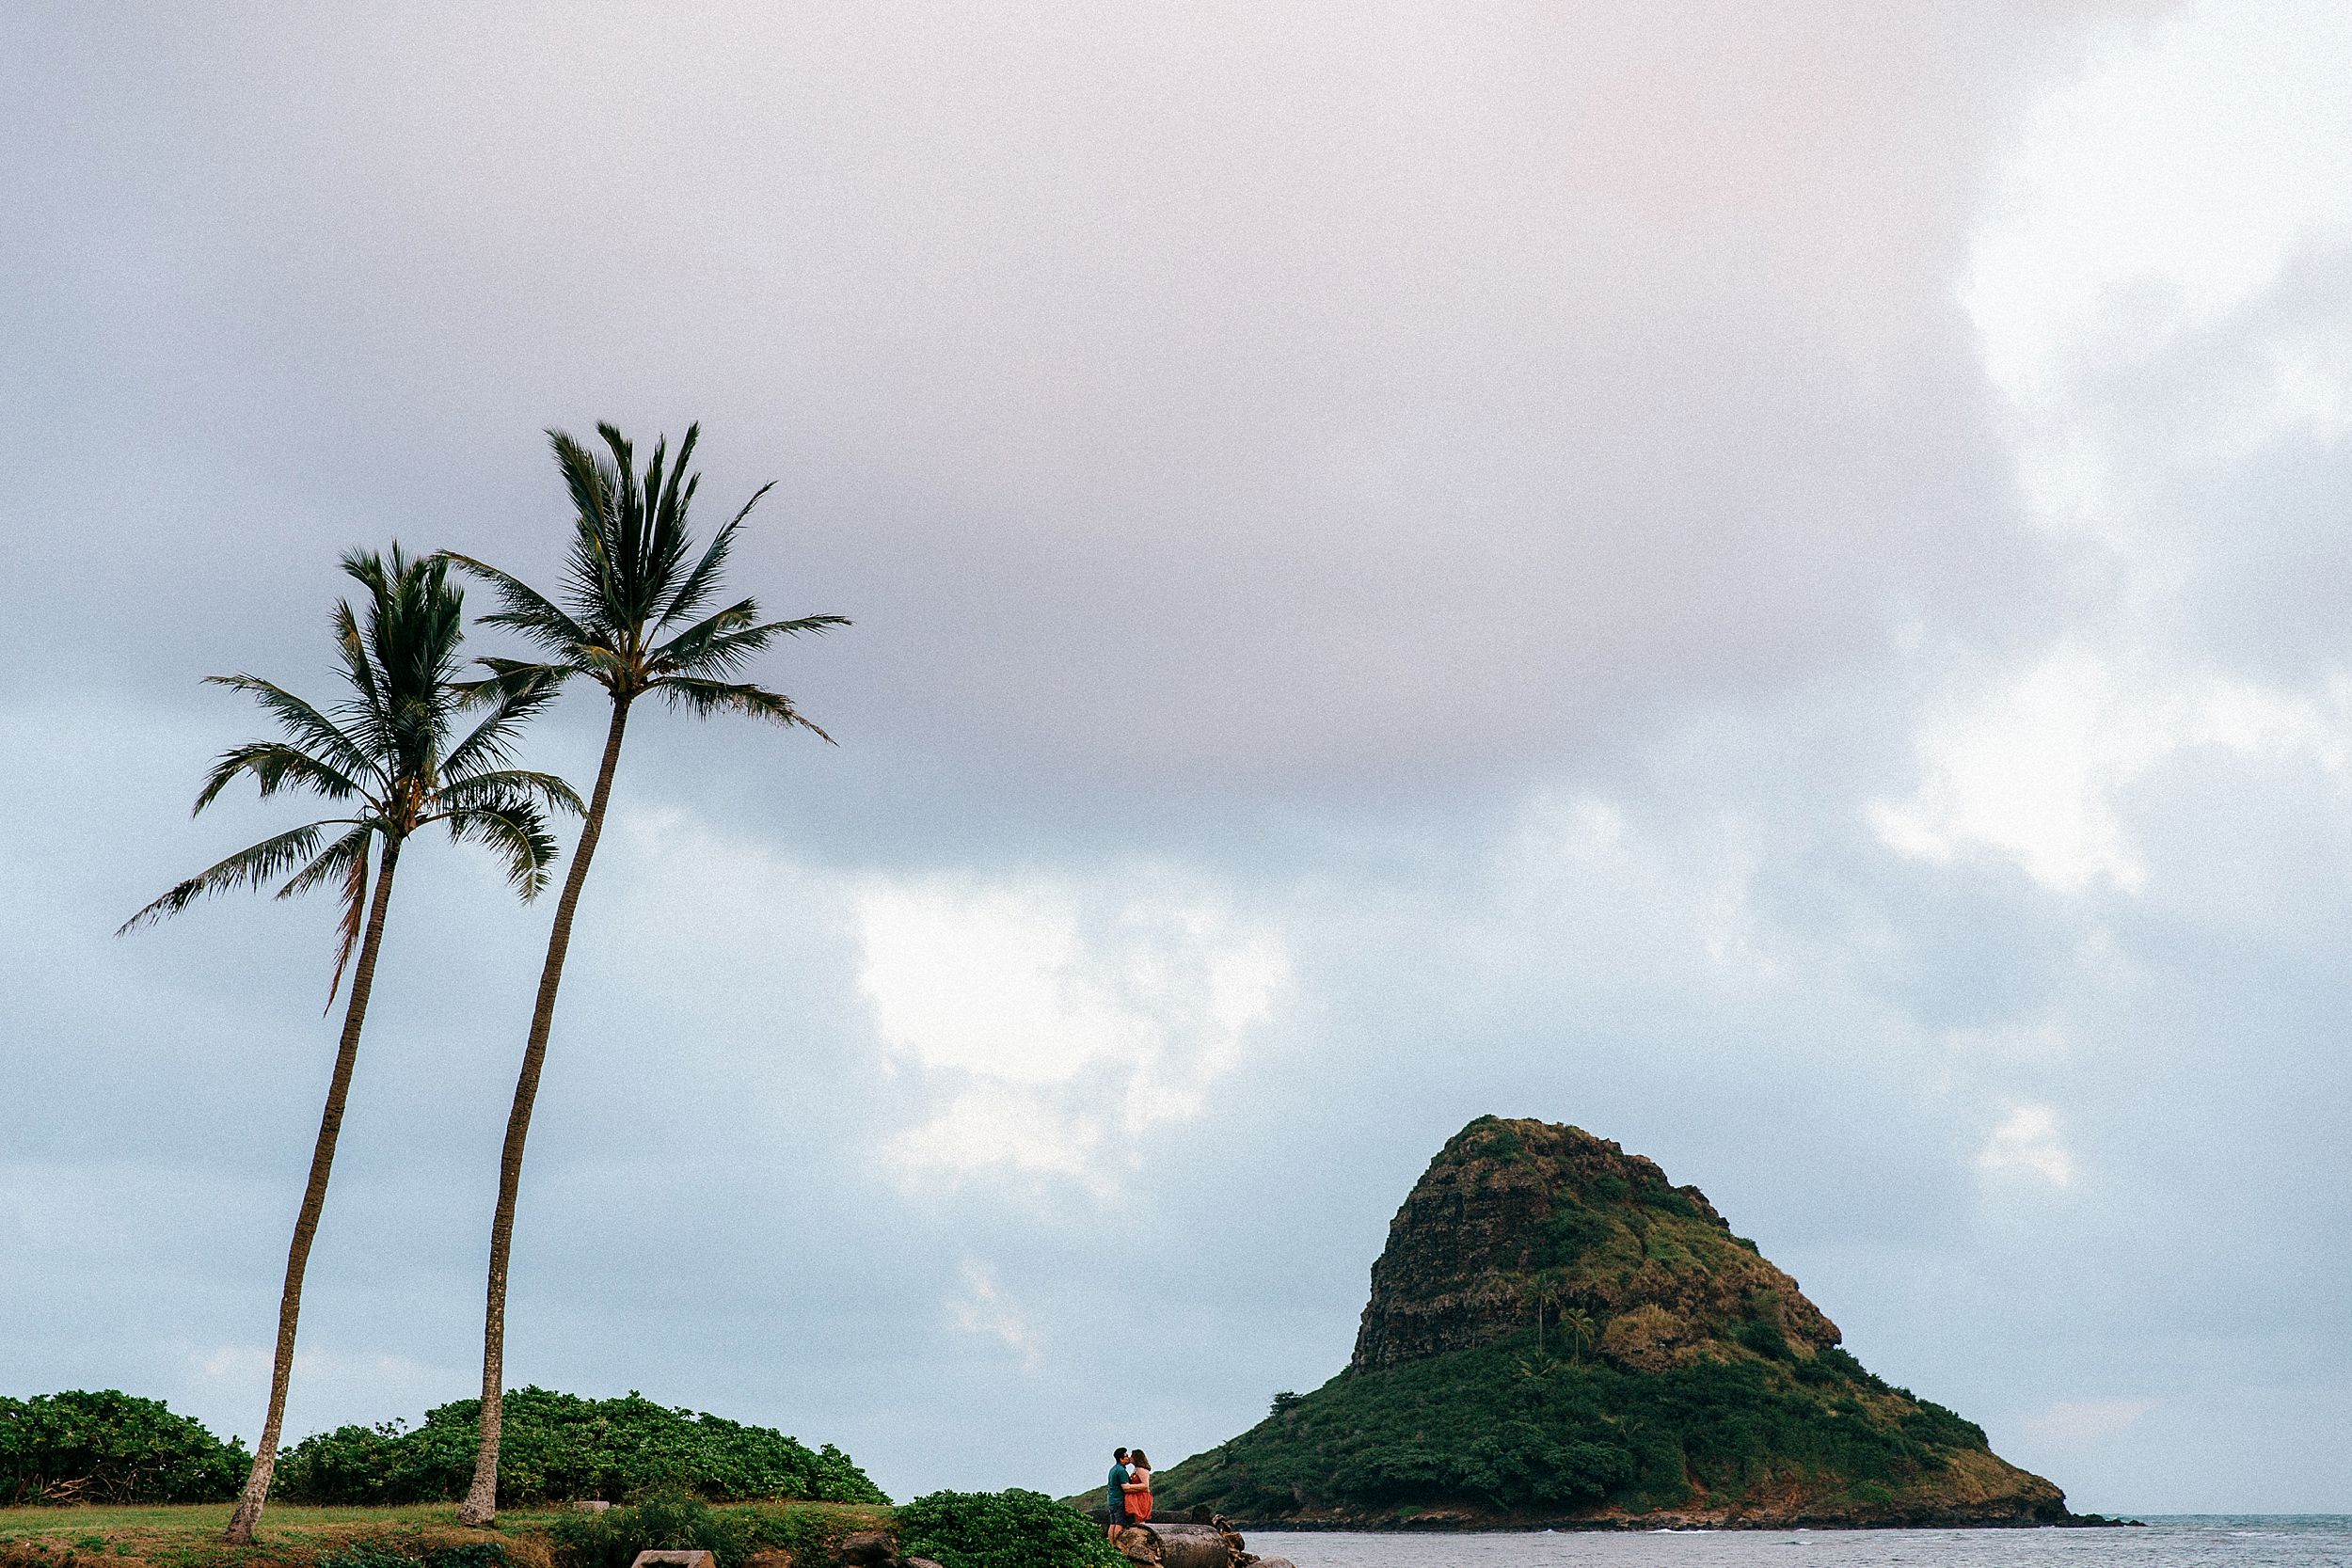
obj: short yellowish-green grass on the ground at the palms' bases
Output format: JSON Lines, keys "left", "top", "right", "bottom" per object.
{"left": 0, "top": 1502, "right": 889, "bottom": 1568}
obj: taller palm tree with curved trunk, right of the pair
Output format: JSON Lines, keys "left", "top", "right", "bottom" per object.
{"left": 450, "top": 423, "right": 850, "bottom": 1524}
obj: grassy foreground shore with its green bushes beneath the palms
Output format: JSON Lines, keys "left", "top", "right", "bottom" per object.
{"left": 0, "top": 1389, "right": 1162, "bottom": 1568}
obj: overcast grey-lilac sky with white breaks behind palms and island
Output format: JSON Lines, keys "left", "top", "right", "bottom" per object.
{"left": 0, "top": 0, "right": 2352, "bottom": 1512}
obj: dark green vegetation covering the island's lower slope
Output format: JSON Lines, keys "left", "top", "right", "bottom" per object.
{"left": 1160, "top": 1333, "right": 1985, "bottom": 1519}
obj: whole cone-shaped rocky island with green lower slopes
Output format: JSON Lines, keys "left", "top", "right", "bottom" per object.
{"left": 1157, "top": 1117, "right": 2074, "bottom": 1528}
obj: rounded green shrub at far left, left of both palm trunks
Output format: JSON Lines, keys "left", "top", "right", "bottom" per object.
{"left": 0, "top": 1389, "right": 254, "bottom": 1507}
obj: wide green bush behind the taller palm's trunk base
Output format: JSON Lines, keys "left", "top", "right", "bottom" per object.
{"left": 278, "top": 1387, "right": 889, "bottom": 1505}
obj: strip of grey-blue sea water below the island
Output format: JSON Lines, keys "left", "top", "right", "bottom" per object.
{"left": 1249, "top": 1514, "right": 2352, "bottom": 1568}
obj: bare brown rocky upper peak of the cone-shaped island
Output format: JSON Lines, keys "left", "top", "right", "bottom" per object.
{"left": 1348, "top": 1117, "right": 1839, "bottom": 1370}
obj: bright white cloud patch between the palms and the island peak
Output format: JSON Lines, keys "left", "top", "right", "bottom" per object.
{"left": 854, "top": 877, "right": 1289, "bottom": 1192}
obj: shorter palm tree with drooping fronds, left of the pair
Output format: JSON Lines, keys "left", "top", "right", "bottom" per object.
{"left": 118, "top": 546, "right": 581, "bottom": 1544}
